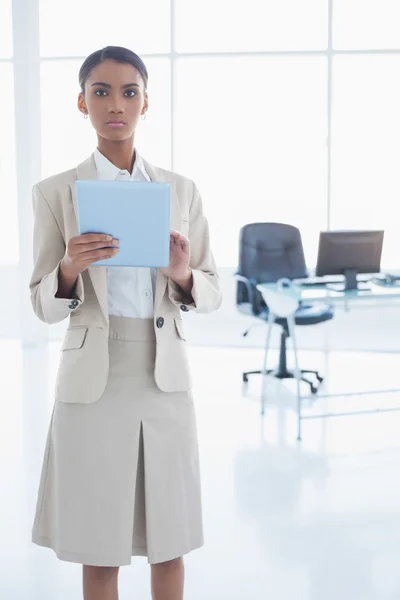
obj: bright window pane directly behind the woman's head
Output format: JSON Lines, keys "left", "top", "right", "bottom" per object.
{"left": 41, "top": 59, "right": 171, "bottom": 177}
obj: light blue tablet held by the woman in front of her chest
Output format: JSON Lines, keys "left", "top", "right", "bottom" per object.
{"left": 76, "top": 180, "right": 170, "bottom": 268}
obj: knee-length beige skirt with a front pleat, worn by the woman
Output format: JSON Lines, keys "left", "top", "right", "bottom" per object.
{"left": 32, "top": 317, "right": 203, "bottom": 567}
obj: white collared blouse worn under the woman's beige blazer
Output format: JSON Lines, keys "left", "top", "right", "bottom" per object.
{"left": 94, "top": 148, "right": 156, "bottom": 319}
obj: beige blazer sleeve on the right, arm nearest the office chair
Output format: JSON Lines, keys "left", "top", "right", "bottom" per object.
{"left": 168, "top": 184, "right": 222, "bottom": 313}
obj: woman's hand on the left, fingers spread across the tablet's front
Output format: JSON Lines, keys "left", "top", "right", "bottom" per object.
{"left": 62, "top": 233, "right": 119, "bottom": 277}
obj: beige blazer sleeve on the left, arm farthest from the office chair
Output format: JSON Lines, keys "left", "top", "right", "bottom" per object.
{"left": 29, "top": 185, "right": 84, "bottom": 324}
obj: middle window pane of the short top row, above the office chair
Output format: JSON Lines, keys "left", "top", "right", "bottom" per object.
{"left": 176, "top": 0, "right": 328, "bottom": 52}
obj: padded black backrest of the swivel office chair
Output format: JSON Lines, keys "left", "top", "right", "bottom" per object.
{"left": 237, "top": 223, "right": 308, "bottom": 312}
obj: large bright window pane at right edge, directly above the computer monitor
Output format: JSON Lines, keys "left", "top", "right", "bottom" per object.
{"left": 331, "top": 56, "right": 400, "bottom": 268}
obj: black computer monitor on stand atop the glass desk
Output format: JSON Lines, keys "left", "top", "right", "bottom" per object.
{"left": 315, "top": 231, "right": 384, "bottom": 291}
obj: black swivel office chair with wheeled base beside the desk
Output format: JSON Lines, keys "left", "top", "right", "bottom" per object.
{"left": 235, "top": 223, "right": 334, "bottom": 394}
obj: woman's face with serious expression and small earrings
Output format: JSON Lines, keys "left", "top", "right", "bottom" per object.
{"left": 78, "top": 60, "right": 148, "bottom": 141}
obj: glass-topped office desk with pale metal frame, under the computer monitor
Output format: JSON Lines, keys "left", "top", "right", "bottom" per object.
{"left": 257, "top": 283, "right": 400, "bottom": 440}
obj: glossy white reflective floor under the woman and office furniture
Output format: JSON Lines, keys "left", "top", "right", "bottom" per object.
{"left": 0, "top": 340, "right": 400, "bottom": 600}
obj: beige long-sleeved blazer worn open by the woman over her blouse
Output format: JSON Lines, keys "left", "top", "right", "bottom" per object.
{"left": 30, "top": 155, "right": 222, "bottom": 403}
